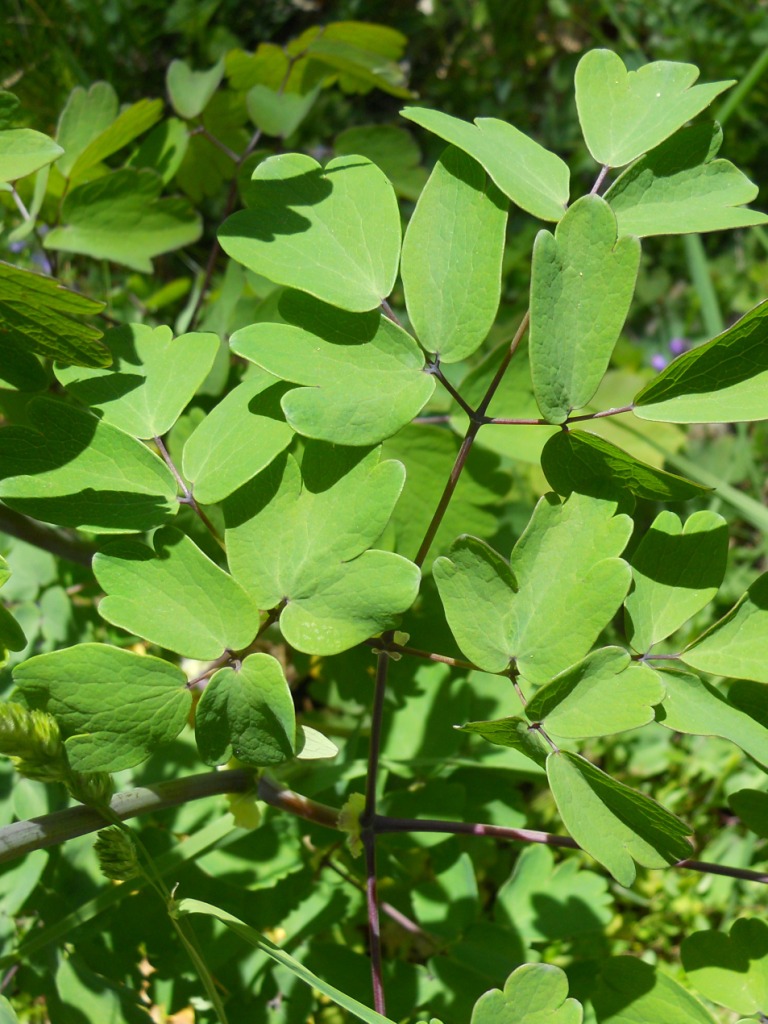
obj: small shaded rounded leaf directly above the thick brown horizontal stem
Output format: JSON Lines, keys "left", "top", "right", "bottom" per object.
{"left": 195, "top": 654, "right": 296, "bottom": 768}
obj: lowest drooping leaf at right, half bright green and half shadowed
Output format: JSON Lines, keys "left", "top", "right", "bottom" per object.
{"left": 547, "top": 751, "right": 691, "bottom": 887}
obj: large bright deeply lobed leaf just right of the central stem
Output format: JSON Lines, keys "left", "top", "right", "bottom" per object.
{"left": 433, "top": 494, "right": 632, "bottom": 683}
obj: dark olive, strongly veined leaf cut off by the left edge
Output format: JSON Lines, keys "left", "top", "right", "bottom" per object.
{"left": 0, "top": 261, "right": 110, "bottom": 367}
